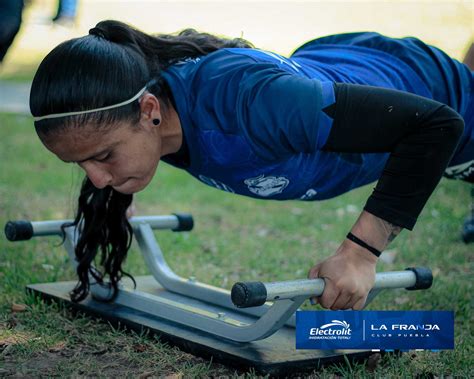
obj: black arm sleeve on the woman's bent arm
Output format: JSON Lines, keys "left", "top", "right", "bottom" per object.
{"left": 323, "top": 83, "right": 464, "bottom": 230}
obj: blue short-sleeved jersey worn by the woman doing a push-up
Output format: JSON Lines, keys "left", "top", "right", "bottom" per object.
{"left": 163, "top": 33, "right": 473, "bottom": 200}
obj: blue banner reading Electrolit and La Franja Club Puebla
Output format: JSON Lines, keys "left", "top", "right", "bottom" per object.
{"left": 296, "top": 311, "right": 454, "bottom": 350}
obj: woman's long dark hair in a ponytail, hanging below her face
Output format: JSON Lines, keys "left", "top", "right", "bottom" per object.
{"left": 30, "top": 20, "right": 252, "bottom": 302}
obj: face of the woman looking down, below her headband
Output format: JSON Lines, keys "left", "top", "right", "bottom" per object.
{"left": 40, "top": 123, "right": 162, "bottom": 194}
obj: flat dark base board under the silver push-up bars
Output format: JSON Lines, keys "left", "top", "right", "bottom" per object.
{"left": 27, "top": 276, "right": 372, "bottom": 375}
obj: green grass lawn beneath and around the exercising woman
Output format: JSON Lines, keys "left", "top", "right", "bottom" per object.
{"left": 0, "top": 114, "right": 474, "bottom": 378}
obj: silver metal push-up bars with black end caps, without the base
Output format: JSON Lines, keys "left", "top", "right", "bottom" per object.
{"left": 5, "top": 214, "right": 432, "bottom": 342}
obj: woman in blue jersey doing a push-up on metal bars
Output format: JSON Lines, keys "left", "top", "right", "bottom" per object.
{"left": 30, "top": 21, "right": 474, "bottom": 309}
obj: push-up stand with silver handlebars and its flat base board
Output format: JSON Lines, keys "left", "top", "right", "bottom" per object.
{"left": 5, "top": 214, "right": 432, "bottom": 375}
